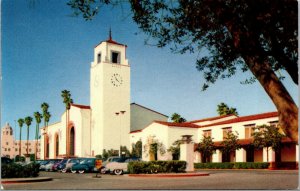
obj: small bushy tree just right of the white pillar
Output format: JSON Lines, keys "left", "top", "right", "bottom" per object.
{"left": 196, "top": 136, "right": 216, "bottom": 162}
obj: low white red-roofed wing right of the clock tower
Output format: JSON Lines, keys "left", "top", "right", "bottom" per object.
{"left": 130, "top": 112, "right": 299, "bottom": 166}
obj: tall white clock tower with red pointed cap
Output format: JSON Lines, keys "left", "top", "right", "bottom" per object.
{"left": 90, "top": 33, "right": 130, "bottom": 155}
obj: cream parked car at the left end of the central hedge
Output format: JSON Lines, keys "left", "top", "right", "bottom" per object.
{"left": 101, "top": 158, "right": 141, "bottom": 175}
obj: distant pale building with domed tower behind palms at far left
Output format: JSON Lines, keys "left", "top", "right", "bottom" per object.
{"left": 1, "top": 123, "right": 41, "bottom": 159}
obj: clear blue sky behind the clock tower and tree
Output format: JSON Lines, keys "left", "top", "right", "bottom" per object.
{"left": 1, "top": 0, "right": 298, "bottom": 139}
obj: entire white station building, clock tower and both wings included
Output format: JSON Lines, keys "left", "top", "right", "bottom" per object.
{"left": 35, "top": 36, "right": 299, "bottom": 166}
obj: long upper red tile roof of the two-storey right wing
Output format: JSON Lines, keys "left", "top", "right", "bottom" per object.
{"left": 201, "top": 111, "right": 278, "bottom": 127}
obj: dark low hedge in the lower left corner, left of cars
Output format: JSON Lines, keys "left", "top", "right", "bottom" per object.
{"left": 1, "top": 163, "right": 40, "bottom": 178}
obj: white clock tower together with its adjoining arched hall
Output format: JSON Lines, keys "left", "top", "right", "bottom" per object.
{"left": 41, "top": 36, "right": 168, "bottom": 159}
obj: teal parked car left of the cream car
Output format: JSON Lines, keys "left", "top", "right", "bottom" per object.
{"left": 71, "top": 158, "right": 102, "bottom": 174}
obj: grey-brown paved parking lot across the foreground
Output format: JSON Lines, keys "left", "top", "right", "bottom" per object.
{"left": 3, "top": 170, "right": 299, "bottom": 190}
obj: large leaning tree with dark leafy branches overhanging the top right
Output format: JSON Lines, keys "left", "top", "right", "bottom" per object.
{"left": 68, "top": 0, "right": 298, "bottom": 141}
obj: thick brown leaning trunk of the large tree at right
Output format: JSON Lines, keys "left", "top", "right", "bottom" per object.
{"left": 244, "top": 55, "right": 298, "bottom": 142}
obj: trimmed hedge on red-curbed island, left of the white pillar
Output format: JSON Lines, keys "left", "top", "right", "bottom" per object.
{"left": 128, "top": 160, "right": 186, "bottom": 174}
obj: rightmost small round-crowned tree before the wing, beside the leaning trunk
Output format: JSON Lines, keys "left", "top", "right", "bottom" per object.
{"left": 252, "top": 125, "right": 284, "bottom": 151}
